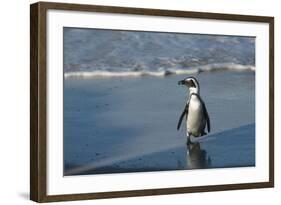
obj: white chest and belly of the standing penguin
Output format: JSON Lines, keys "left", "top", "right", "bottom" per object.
{"left": 186, "top": 96, "right": 205, "bottom": 137}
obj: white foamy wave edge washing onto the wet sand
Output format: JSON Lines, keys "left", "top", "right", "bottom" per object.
{"left": 64, "top": 63, "right": 255, "bottom": 78}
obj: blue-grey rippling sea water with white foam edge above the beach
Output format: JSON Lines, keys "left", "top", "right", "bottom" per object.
{"left": 64, "top": 28, "right": 255, "bottom": 77}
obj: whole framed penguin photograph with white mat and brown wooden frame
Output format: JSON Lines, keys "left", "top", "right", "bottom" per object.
{"left": 30, "top": 2, "right": 274, "bottom": 202}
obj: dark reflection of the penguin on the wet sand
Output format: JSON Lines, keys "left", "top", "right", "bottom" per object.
{"left": 186, "top": 142, "right": 211, "bottom": 169}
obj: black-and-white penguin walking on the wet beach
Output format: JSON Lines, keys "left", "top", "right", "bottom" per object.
{"left": 177, "top": 77, "right": 211, "bottom": 145}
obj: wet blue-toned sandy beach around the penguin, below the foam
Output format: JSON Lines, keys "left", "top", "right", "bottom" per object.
{"left": 63, "top": 71, "right": 255, "bottom": 176}
